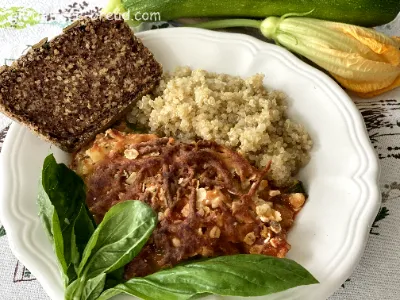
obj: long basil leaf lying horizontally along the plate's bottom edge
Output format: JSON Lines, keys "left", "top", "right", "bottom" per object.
{"left": 99, "top": 254, "right": 318, "bottom": 300}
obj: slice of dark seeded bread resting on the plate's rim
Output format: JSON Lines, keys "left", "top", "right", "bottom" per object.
{"left": 0, "top": 18, "right": 162, "bottom": 152}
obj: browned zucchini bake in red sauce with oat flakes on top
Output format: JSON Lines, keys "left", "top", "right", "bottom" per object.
{"left": 71, "top": 129, "right": 306, "bottom": 279}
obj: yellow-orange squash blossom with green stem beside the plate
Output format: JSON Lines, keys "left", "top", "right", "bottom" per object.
{"left": 194, "top": 14, "right": 400, "bottom": 98}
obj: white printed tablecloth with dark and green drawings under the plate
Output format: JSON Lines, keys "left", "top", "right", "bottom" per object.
{"left": 0, "top": 0, "right": 400, "bottom": 300}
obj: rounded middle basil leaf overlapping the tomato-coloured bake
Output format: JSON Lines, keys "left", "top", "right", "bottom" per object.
{"left": 78, "top": 200, "right": 157, "bottom": 278}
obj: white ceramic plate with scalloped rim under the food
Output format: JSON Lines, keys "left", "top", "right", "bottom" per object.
{"left": 0, "top": 28, "right": 380, "bottom": 300}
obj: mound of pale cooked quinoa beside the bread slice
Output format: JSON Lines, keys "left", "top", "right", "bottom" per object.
{"left": 128, "top": 67, "right": 312, "bottom": 186}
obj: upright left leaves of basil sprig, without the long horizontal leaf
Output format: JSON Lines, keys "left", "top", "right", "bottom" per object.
{"left": 38, "top": 155, "right": 157, "bottom": 300}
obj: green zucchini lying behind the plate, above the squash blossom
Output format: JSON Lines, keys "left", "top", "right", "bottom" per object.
{"left": 104, "top": 0, "right": 400, "bottom": 26}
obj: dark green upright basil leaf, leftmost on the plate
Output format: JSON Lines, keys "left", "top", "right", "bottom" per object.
{"left": 38, "top": 154, "right": 95, "bottom": 285}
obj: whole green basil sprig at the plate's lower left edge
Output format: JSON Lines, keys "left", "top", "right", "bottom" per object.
{"left": 38, "top": 155, "right": 318, "bottom": 300}
